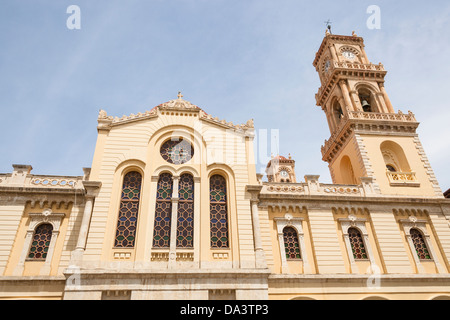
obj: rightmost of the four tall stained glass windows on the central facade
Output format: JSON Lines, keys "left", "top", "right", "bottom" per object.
{"left": 210, "top": 175, "right": 229, "bottom": 248}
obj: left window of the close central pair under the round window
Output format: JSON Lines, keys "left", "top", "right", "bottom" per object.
{"left": 153, "top": 173, "right": 173, "bottom": 248}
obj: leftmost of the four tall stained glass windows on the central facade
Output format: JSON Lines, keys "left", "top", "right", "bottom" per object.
{"left": 114, "top": 171, "right": 142, "bottom": 248}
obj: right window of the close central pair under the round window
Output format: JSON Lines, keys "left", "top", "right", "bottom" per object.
{"left": 177, "top": 174, "right": 194, "bottom": 248}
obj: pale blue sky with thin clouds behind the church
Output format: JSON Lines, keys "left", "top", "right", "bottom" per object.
{"left": 0, "top": 0, "right": 450, "bottom": 190}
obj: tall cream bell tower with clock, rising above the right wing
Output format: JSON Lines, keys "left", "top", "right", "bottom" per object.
{"left": 313, "top": 30, "right": 442, "bottom": 197}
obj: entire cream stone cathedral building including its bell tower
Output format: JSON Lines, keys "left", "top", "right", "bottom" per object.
{"left": 0, "top": 32, "right": 450, "bottom": 300}
